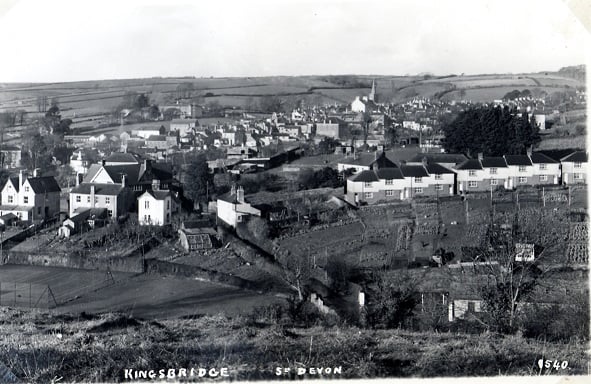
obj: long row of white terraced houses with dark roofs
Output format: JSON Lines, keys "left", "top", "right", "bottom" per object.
{"left": 339, "top": 151, "right": 587, "bottom": 204}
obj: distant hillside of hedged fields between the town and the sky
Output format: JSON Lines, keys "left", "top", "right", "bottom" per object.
{"left": 0, "top": 66, "right": 585, "bottom": 118}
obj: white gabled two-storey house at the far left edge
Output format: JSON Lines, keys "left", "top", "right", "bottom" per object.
{"left": 0, "top": 171, "right": 61, "bottom": 222}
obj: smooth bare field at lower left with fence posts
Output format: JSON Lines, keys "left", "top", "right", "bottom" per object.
{"left": 0, "top": 265, "right": 281, "bottom": 318}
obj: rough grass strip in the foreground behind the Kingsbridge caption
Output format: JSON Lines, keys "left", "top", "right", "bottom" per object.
{"left": 0, "top": 308, "right": 588, "bottom": 382}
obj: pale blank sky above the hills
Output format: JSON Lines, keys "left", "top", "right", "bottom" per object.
{"left": 0, "top": 0, "right": 591, "bottom": 82}
